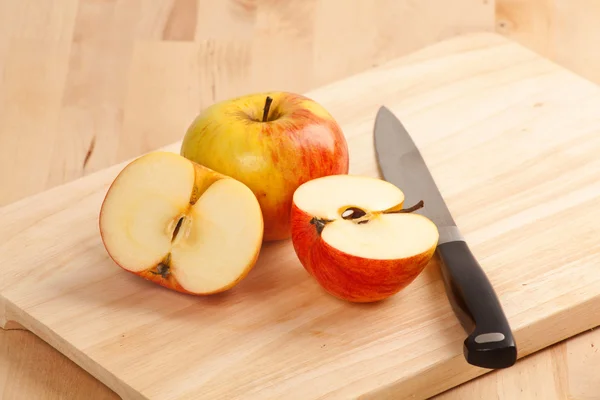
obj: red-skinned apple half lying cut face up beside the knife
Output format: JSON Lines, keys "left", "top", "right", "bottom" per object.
{"left": 291, "top": 175, "right": 438, "bottom": 302}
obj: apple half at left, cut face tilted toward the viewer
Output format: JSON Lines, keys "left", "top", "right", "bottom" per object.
{"left": 100, "top": 151, "right": 263, "bottom": 295}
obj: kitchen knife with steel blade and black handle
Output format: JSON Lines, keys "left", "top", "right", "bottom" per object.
{"left": 374, "top": 107, "right": 517, "bottom": 369}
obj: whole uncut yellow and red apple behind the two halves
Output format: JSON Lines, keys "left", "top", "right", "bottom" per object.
{"left": 181, "top": 92, "right": 349, "bottom": 241}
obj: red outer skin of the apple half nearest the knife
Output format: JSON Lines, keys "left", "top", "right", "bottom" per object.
{"left": 291, "top": 204, "right": 435, "bottom": 303}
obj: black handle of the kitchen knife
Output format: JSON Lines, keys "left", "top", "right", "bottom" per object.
{"left": 438, "top": 240, "right": 517, "bottom": 369}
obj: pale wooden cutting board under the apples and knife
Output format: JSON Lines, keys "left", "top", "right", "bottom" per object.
{"left": 0, "top": 34, "right": 600, "bottom": 400}
